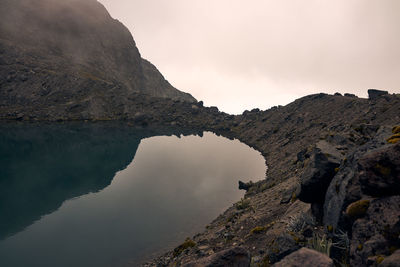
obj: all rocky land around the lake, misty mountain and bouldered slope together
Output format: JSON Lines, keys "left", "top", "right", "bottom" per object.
{"left": 0, "top": 0, "right": 400, "bottom": 266}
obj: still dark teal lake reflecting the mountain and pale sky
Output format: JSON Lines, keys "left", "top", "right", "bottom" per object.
{"left": 0, "top": 124, "right": 266, "bottom": 267}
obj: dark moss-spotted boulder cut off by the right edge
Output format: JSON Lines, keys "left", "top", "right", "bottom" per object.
{"left": 359, "top": 143, "right": 400, "bottom": 197}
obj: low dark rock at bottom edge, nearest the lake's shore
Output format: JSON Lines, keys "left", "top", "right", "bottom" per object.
{"left": 183, "top": 247, "right": 251, "bottom": 267}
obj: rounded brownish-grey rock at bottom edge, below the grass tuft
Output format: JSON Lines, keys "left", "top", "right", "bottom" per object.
{"left": 272, "top": 248, "right": 334, "bottom": 267}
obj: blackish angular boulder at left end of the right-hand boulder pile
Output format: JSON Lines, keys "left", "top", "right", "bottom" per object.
{"left": 299, "top": 148, "right": 339, "bottom": 203}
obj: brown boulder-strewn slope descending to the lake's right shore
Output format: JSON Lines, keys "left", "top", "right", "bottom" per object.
{"left": 144, "top": 91, "right": 400, "bottom": 266}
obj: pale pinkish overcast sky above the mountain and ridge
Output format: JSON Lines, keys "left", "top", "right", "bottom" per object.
{"left": 99, "top": 0, "right": 400, "bottom": 113}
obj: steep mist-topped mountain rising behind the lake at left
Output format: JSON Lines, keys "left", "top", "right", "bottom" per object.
{"left": 0, "top": 0, "right": 196, "bottom": 118}
